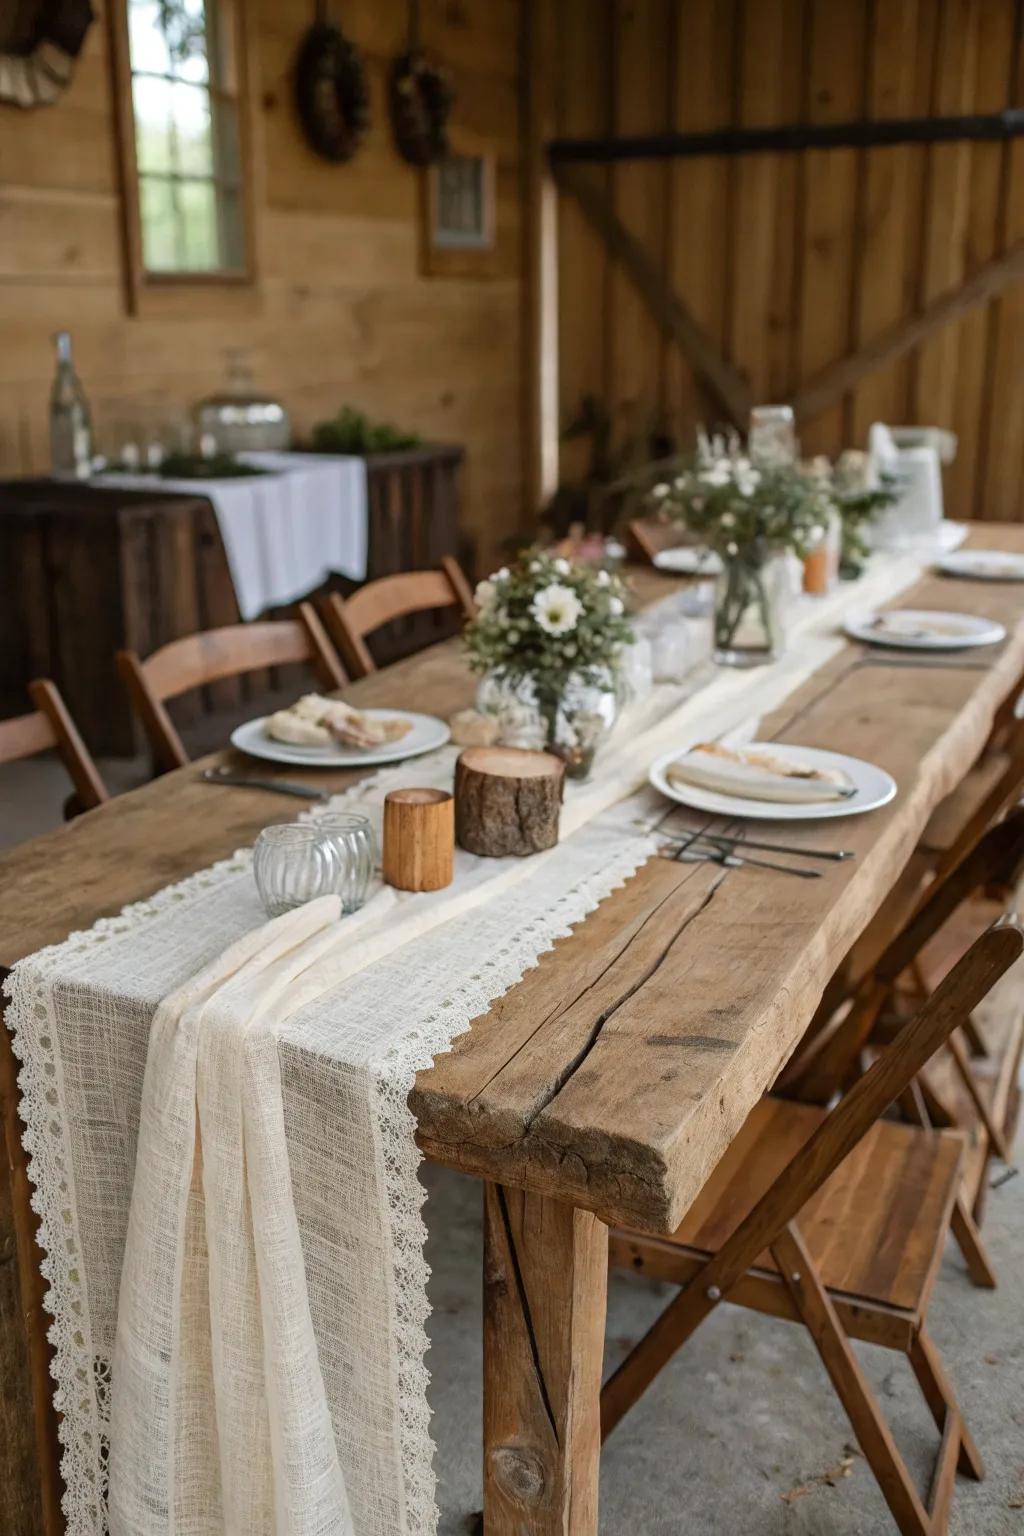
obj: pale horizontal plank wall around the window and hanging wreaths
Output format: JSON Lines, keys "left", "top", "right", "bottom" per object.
{"left": 0, "top": 0, "right": 522, "bottom": 561}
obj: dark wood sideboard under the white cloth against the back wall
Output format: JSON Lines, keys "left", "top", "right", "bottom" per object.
{"left": 0, "top": 447, "right": 471, "bottom": 754}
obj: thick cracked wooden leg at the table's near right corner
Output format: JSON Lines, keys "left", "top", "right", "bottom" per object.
{"left": 484, "top": 1184, "right": 608, "bottom": 1536}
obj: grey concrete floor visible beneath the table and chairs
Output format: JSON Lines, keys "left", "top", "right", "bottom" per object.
{"left": 0, "top": 759, "right": 1024, "bottom": 1536}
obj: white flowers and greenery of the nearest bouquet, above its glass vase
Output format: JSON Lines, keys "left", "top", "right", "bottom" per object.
{"left": 465, "top": 548, "right": 633, "bottom": 705}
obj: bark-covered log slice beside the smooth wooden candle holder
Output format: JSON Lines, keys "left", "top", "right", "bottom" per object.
{"left": 454, "top": 746, "right": 565, "bottom": 859}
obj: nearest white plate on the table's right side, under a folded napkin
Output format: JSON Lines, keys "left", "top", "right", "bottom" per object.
{"left": 649, "top": 742, "right": 897, "bottom": 822}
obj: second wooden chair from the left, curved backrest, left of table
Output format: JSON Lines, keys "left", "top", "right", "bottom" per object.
{"left": 117, "top": 602, "right": 348, "bottom": 773}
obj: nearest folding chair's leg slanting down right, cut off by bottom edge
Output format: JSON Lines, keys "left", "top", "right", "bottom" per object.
{"left": 772, "top": 1224, "right": 933, "bottom": 1536}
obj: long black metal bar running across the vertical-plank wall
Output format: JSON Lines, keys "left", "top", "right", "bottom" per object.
{"left": 548, "top": 108, "right": 1024, "bottom": 164}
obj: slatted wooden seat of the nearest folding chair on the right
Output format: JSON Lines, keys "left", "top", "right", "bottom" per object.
{"left": 616, "top": 1098, "right": 964, "bottom": 1318}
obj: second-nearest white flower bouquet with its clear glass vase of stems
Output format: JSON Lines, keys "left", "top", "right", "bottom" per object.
{"left": 649, "top": 433, "right": 831, "bottom": 667}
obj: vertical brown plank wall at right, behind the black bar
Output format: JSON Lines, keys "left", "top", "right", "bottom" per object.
{"left": 554, "top": 0, "right": 1024, "bottom": 519}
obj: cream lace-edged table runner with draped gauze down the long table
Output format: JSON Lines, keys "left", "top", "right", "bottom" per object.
{"left": 8, "top": 543, "right": 957, "bottom": 1536}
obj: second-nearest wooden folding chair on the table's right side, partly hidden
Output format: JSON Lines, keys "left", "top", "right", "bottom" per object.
{"left": 775, "top": 806, "right": 1024, "bottom": 1287}
